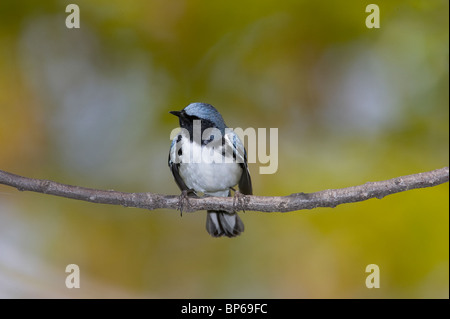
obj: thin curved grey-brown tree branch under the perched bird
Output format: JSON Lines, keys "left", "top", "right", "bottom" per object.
{"left": 0, "top": 167, "right": 449, "bottom": 212}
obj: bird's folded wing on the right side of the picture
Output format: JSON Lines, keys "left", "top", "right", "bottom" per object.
{"left": 224, "top": 131, "right": 253, "bottom": 195}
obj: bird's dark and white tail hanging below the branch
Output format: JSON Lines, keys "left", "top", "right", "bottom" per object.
{"left": 206, "top": 210, "right": 244, "bottom": 237}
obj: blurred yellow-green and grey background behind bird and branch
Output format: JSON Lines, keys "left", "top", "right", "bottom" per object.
{"left": 0, "top": 0, "right": 449, "bottom": 298}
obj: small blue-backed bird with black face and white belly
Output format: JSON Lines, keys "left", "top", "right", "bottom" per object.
{"left": 169, "top": 103, "right": 253, "bottom": 237}
